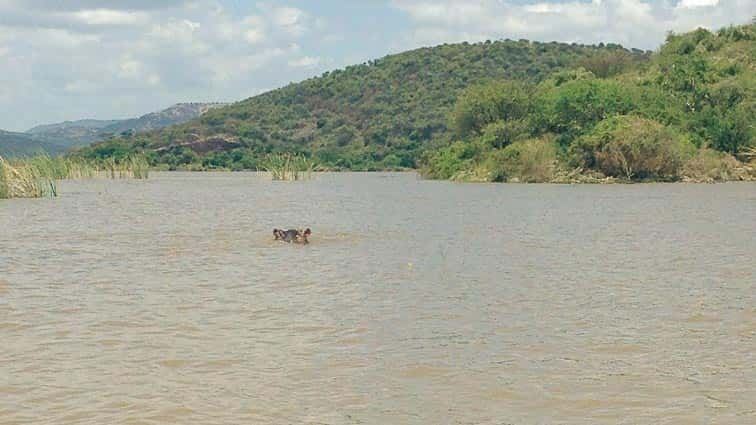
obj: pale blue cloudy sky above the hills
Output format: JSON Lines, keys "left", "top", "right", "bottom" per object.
{"left": 0, "top": 0, "right": 756, "bottom": 131}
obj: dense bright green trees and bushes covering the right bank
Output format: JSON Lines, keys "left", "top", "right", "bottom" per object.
{"left": 423, "top": 24, "right": 756, "bottom": 181}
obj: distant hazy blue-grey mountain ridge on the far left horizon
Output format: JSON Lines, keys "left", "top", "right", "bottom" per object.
{"left": 18, "top": 103, "right": 226, "bottom": 153}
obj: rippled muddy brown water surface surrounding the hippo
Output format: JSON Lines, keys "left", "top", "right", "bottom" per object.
{"left": 0, "top": 173, "right": 756, "bottom": 425}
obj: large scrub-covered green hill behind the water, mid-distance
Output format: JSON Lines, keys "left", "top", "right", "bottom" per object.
{"left": 81, "top": 40, "right": 648, "bottom": 170}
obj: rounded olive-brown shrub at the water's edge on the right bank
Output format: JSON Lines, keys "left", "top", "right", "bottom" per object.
{"left": 570, "top": 115, "right": 695, "bottom": 180}
